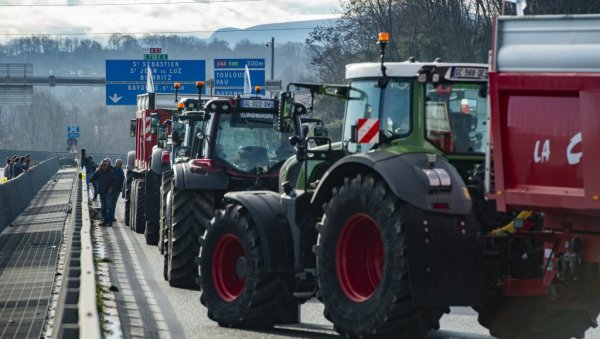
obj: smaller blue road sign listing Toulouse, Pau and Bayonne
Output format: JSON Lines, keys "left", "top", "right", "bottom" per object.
{"left": 214, "top": 59, "right": 265, "bottom": 95}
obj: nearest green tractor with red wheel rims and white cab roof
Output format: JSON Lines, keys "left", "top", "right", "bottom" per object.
{"left": 198, "top": 32, "right": 488, "bottom": 338}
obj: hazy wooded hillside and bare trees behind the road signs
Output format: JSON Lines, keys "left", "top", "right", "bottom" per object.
{"left": 0, "top": 0, "right": 600, "bottom": 153}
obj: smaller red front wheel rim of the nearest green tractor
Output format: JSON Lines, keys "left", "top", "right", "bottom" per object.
{"left": 212, "top": 234, "right": 246, "bottom": 302}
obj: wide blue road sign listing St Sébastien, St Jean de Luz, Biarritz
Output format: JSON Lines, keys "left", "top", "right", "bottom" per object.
{"left": 106, "top": 59, "right": 206, "bottom": 106}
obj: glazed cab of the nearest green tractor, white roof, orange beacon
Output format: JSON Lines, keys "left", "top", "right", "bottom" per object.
{"left": 342, "top": 33, "right": 489, "bottom": 156}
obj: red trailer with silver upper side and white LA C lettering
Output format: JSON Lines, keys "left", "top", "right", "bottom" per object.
{"left": 479, "top": 15, "right": 600, "bottom": 338}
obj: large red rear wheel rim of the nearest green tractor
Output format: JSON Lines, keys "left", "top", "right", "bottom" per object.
{"left": 335, "top": 213, "right": 384, "bottom": 302}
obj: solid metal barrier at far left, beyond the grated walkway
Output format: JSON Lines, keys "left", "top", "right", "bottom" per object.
{"left": 0, "top": 158, "right": 58, "bottom": 232}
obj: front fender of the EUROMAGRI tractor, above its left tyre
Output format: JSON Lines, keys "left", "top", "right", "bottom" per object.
{"left": 173, "top": 161, "right": 229, "bottom": 190}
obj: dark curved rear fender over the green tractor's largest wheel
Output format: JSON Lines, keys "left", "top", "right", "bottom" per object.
{"left": 311, "top": 151, "right": 472, "bottom": 215}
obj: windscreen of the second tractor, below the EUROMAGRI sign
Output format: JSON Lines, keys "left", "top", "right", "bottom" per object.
{"left": 213, "top": 112, "right": 295, "bottom": 173}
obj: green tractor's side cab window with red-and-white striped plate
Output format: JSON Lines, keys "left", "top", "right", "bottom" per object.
{"left": 343, "top": 79, "right": 412, "bottom": 153}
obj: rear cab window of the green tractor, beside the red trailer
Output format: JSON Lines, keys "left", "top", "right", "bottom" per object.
{"left": 425, "top": 82, "right": 488, "bottom": 153}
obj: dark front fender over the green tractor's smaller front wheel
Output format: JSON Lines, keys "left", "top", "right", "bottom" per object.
{"left": 225, "top": 191, "right": 294, "bottom": 272}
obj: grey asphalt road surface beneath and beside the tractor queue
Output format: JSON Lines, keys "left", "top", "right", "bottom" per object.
{"left": 100, "top": 200, "right": 600, "bottom": 339}
